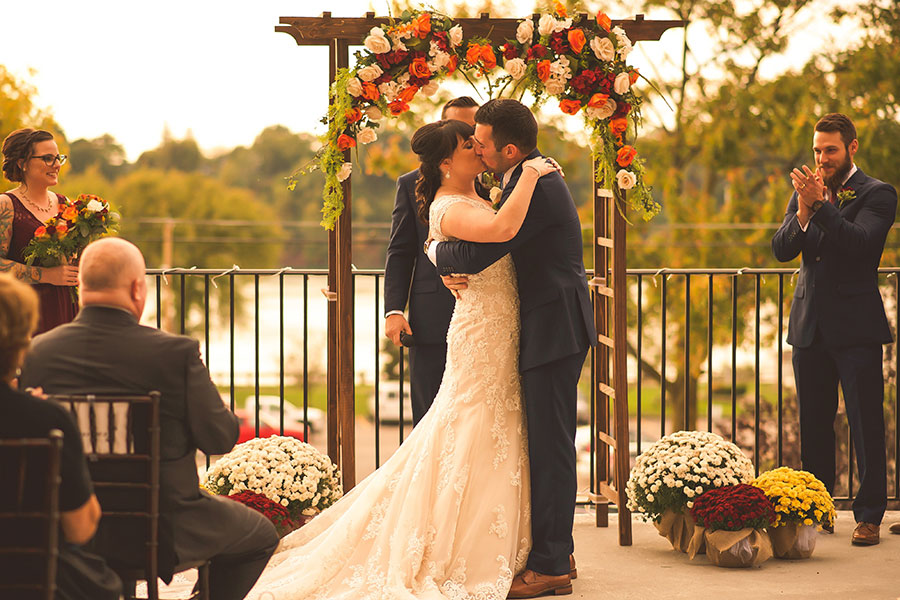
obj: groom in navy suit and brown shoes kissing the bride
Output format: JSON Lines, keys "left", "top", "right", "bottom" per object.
{"left": 429, "top": 99, "right": 597, "bottom": 598}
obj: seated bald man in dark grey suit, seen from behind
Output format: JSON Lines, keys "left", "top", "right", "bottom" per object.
{"left": 19, "top": 237, "right": 278, "bottom": 600}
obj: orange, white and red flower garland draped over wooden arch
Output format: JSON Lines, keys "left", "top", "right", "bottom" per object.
{"left": 302, "top": 3, "right": 660, "bottom": 229}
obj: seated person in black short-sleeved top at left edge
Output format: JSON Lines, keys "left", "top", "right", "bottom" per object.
{"left": 0, "top": 274, "right": 122, "bottom": 600}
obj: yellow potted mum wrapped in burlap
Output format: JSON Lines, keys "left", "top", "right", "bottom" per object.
{"left": 753, "top": 467, "right": 835, "bottom": 559}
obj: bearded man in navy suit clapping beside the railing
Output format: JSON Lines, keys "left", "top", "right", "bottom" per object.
{"left": 772, "top": 113, "right": 897, "bottom": 545}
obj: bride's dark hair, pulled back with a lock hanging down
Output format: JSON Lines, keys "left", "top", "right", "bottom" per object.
{"left": 410, "top": 119, "right": 475, "bottom": 223}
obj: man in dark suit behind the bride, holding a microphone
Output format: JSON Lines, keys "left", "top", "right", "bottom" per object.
{"left": 384, "top": 96, "right": 478, "bottom": 424}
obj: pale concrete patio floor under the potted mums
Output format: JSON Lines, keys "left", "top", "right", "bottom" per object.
{"left": 149, "top": 509, "right": 900, "bottom": 600}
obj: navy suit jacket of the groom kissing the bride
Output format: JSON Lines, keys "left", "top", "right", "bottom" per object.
{"left": 437, "top": 150, "right": 597, "bottom": 371}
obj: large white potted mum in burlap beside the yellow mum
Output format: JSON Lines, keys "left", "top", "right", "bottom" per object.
{"left": 626, "top": 431, "right": 753, "bottom": 552}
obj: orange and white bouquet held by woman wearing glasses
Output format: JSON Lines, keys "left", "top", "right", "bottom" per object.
{"left": 23, "top": 194, "right": 119, "bottom": 267}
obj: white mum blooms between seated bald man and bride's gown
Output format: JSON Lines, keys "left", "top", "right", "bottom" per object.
{"left": 203, "top": 435, "right": 344, "bottom": 518}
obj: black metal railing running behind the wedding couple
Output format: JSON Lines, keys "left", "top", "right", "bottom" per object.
{"left": 148, "top": 267, "right": 900, "bottom": 502}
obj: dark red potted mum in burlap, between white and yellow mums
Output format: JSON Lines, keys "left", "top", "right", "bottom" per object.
{"left": 688, "top": 483, "right": 775, "bottom": 567}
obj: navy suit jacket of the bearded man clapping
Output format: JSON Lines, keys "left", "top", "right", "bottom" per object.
{"left": 772, "top": 169, "right": 897, "bottom": 348}
